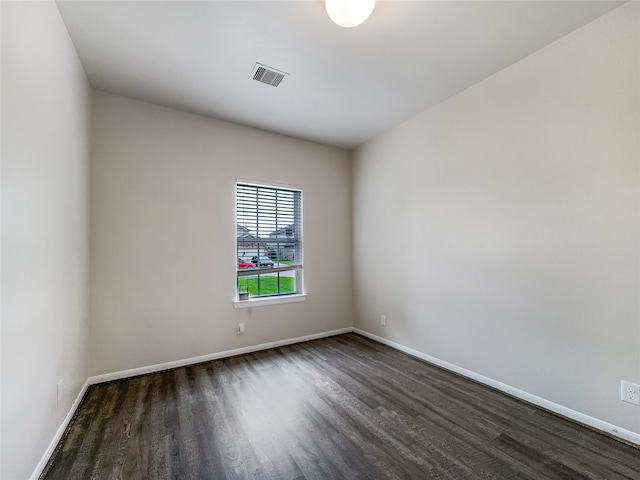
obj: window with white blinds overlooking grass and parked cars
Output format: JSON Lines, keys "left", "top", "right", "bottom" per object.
{"left": 236, "top": 183, "right": 303, "bottom": 301}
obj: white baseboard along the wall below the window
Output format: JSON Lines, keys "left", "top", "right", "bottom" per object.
{"left": 88, "top": 327, "right": 353, "bottom": 385}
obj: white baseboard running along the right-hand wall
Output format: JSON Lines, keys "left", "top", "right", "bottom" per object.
{"left": 353, "top": 328, "right": 640, "bottom": 446}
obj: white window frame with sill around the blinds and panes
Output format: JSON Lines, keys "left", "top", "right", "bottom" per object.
{"left": 233, "top": 178, "right": 307, "bottom": 308}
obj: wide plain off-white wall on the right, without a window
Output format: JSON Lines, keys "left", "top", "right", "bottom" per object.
{"left": 353, "top": 2, "right": 640, "bottom": 433}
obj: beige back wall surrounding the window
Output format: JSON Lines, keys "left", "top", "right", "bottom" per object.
{"left": 90, "top": 92, "right": 352, "bottom": 375}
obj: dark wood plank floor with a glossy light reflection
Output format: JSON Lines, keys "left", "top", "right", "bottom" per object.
{"left": 41, "top": 334, "right": 640, "bottom": 480}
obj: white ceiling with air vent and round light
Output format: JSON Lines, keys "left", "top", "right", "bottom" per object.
{"left": 57, "top": 0, "right": 622, "bottom": 149}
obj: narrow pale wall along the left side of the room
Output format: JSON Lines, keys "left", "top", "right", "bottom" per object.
{"left": 0, "top": 1, "right": 91, "bottom": 480}
